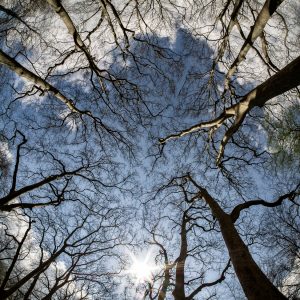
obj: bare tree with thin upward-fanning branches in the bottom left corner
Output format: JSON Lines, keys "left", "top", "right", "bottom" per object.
{"left": 0, "top": 203, "right": 124, "bottom": 299}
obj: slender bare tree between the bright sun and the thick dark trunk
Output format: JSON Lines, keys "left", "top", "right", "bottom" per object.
{"left": 142, "top": 178, "right": 230, "bottom": 300}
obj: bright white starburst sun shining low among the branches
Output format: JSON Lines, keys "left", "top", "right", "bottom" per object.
{"left": 127, "top": 252, "right": 158, "bottom": 283}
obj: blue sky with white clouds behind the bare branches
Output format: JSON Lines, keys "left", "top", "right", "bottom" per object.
{"left": 0, "top": 0, "right": 300, "bottom": 299}
